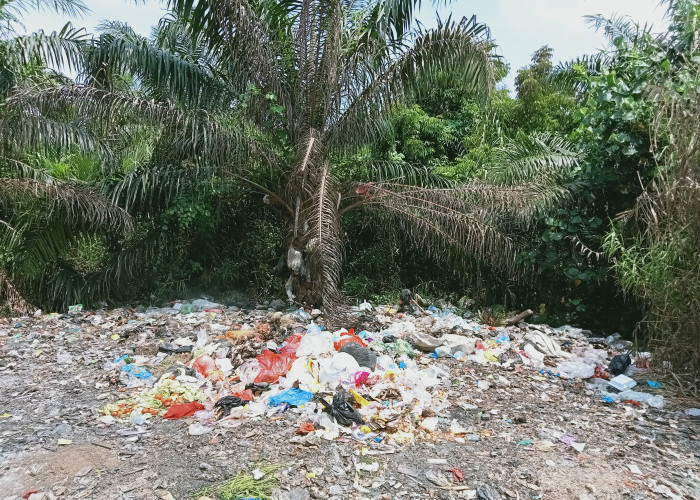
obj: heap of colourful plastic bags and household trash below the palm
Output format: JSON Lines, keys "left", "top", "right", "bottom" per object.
{"left": 94, "top": 300, "right": 665, "bottom": 444}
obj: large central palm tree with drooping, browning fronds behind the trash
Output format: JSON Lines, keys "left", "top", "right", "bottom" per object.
{"left": 2, "top": 0, "right": 576, "bottom": 309}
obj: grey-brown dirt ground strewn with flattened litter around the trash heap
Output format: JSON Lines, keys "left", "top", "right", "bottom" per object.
{"left": 0, "top": 310, "right": 700, "bottom": 500}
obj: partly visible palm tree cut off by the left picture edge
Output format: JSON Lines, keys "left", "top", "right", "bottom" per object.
{"left": 0, "top": 0, "right": 131, "bottom": 311}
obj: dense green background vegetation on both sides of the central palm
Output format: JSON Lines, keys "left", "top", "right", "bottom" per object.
{"left": 0, "top": 0, "right": 700, "bottom": 382}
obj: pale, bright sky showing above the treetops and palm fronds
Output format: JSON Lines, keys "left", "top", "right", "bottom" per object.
{"left": 24, "top": 0, "right": 665, "bottom": 90}
